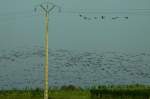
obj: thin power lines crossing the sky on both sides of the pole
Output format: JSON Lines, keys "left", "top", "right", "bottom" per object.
{"left": 0, "top": 8, "right": 150, "bottom": 17}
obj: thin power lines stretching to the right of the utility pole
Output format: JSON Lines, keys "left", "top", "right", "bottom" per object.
{"left": 58, "top": 8, "right": 150, "bottom": 15}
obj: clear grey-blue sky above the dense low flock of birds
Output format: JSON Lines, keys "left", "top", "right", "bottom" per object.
{"left": 0, "top": 0, "right": 150, "bottom": 52}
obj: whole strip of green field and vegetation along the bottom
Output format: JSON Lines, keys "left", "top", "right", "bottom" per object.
{"left": 0, "top": 85, "right": 150, "bottom": 99}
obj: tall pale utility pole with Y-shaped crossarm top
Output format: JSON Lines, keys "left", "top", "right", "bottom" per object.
{"left": 35, "top": 2, "right": 60, "bottom": 99}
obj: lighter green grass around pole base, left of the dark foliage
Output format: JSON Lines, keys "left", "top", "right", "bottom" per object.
{"left": 0, "top": 90, "right": 90, "bottom": 99}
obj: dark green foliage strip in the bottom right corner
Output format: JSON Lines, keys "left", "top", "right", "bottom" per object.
{"left": 90, "top": 84, "right": 150, "bottom": 99}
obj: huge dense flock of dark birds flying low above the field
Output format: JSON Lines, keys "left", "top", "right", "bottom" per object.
{"left": 0, "top": 47, "right": 150, "bottom": 89}
